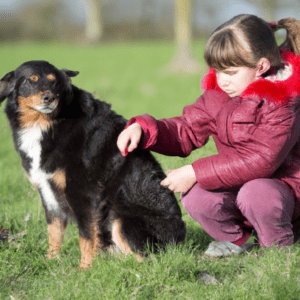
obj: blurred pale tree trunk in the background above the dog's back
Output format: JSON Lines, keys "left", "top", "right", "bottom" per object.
{"left": 85, "top": 0, "right": 103, "bottom": 43}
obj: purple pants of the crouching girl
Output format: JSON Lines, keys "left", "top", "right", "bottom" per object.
{"left": 181, "top": 179, "right": 300, "bottom": 247}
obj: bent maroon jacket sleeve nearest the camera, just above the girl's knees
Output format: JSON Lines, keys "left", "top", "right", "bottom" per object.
{"left": 192, "top": 98, "right": 300, "bottom": 190}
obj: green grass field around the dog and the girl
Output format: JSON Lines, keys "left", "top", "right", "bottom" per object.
{"left": 0, "top": 42, "right": 300, "bottom": 300}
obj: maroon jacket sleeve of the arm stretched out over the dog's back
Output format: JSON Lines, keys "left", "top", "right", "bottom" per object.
{"left": 127, "top": 95, "right": 215, "bottom": 157}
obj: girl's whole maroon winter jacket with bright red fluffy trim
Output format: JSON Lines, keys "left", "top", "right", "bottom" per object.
{"left": 127, "top": 52, "right": 300, "bottom": 199}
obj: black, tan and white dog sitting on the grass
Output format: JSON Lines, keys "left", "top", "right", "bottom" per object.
{"left": 0, "top": 61, "right": 185, "bottom": 268}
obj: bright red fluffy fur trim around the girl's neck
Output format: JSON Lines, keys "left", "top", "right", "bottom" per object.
{"left": 201, "top": 50, "right": 300, "bottom": 105}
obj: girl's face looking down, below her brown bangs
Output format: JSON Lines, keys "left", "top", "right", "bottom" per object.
{"left": 216, "top": 67, "right": 260, "bottom": 97}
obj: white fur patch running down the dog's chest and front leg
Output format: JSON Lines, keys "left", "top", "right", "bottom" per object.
{"left": 19, "top": 127, "right": 60, "bottom": 212}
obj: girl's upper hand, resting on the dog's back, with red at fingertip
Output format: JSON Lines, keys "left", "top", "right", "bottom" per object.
{"left": 117, "top": 123, "right": 143, "bottom": 157}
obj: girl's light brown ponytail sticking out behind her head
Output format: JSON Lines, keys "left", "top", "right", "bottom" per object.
{"left": 269, "top": 18, "right": 300, "bottom": 55}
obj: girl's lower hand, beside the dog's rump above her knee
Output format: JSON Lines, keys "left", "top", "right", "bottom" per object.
{"left": 160, "top": 165, "right": 197, "bottom": 194}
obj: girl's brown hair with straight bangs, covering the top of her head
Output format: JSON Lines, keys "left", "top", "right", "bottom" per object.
{"left": 204, "top": 14, "right": 300, "bottom": 71}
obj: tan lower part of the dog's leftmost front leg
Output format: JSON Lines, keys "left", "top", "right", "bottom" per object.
{"left": 47, "top": 217, "right": 67, "bottom": 259}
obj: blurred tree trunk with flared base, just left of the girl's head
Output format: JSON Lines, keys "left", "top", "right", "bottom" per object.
{"left": 167, "top": 0, "right": 200, "bottom": 73}
